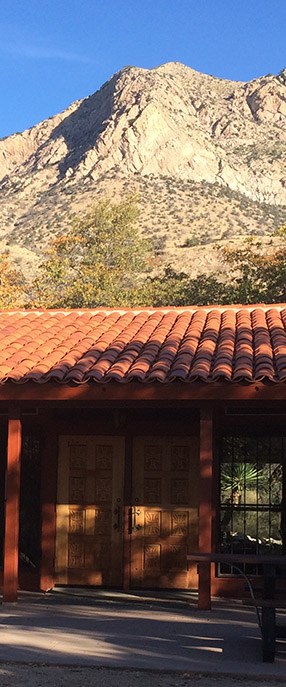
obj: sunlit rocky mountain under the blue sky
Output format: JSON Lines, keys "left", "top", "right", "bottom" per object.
{"left": 0, "top": 63, "right": 286, "bottom": 274}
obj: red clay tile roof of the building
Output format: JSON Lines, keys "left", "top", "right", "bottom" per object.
{"left": 0, "top": 304, "right": 286, "bottom": 384}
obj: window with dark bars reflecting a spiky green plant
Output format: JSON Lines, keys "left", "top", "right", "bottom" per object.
{"left": 220, "top": 436, "right": 286, "bottom": 574}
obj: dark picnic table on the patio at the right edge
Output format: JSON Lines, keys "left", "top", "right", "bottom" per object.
{"left": 187, "top": 552, "right": 286, "bottom": 663}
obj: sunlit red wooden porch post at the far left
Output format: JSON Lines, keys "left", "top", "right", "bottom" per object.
{"left": 3, "top": 408, "right": 22, "bottom": 601}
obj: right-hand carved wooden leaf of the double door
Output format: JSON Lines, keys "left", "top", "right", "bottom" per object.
{"left": 131, "top": 437, "right": 198, "bottom": 588}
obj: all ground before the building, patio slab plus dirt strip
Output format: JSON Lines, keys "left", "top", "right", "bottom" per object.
{"left": 0, "top": 593, "right": 286, "bottom": 687}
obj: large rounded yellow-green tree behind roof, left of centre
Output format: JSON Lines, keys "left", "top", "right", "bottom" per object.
{"left": 33, "top": 197, "right": 149, "bottom": 308}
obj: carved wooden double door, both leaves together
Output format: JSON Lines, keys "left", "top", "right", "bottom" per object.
{"left": 55, "top": 436, "right": 198, "bottom": 589}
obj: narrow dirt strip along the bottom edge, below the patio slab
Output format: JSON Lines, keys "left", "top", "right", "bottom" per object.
{"left": 0, "top": 663, "right": 286, "bottom": 687}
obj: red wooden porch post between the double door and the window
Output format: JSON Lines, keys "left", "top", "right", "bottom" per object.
{"left": 198, "top": 407, "right": 213, "bottom": 610}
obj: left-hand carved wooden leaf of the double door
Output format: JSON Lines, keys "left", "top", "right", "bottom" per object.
{"left": 55, "top": 436, "right": 124, "bottom": 586}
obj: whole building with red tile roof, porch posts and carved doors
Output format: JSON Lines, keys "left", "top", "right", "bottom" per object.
{"left": 0, "top": 304, "right": 286, "bottom": 600}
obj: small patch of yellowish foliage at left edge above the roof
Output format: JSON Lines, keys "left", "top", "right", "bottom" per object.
{"left": 0, "top": 251, "right": 27, "bottom": 310}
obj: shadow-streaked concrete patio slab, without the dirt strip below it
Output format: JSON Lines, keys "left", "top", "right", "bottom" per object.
{"left": 0, "top": 589, "right": 286, "bottom": 680}
